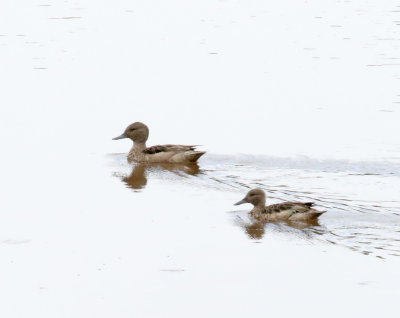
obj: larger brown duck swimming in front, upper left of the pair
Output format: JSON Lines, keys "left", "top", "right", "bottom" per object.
{"left": 113, "top": 122, "right": 206, "bottom": 163}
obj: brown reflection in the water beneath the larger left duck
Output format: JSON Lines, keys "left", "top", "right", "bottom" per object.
{"left": 120, "top": 163, "right": 201, "bottom": 190}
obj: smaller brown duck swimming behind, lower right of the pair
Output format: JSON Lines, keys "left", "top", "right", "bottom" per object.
{"left": 234, "top": 189, "right": 326, "bottom": 222}
